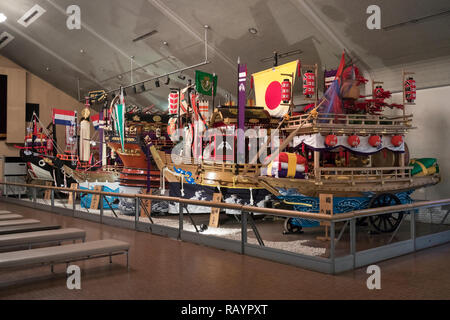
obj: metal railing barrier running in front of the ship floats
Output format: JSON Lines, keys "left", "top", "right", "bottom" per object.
{"left": 0, "top": 182, "right": 450, "bottom": 273}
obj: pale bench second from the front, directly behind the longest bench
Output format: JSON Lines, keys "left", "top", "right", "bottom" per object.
{"left": 0, "top": 228, "right": 86, "bottom": 249}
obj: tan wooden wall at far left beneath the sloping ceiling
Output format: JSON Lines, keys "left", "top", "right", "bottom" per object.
{"left": 0, "top": 55, "right": 83, "bottom": 156}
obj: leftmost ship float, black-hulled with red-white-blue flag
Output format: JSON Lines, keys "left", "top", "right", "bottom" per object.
{"left": 17, "top": 92, "right": 118, "bottom": 187}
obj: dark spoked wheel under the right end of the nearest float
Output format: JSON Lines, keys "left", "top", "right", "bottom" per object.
{"left": 369, "top": 193, "right": 403, "bottom": 233}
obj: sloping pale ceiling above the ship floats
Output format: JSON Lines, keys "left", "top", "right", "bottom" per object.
{"left": 0, "top": 0, "right": 450, "bottom": 109}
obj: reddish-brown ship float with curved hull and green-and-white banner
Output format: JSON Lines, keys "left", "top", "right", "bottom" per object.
{"left": 104, "top": 93, "right": 172, "bottom": 214}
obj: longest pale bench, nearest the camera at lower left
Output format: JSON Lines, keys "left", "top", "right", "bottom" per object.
{"left": 0, "top": 239, "right": 130, "bottom": 272}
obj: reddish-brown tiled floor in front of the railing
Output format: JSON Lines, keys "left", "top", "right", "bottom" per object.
{"left": 0, "top": 202, "right": 450, "bottom": 299}
